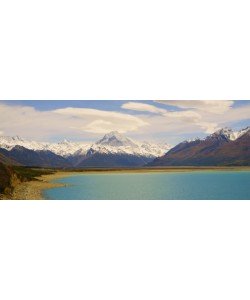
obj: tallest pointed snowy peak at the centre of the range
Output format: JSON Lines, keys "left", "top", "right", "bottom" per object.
{"left": 96, "top": 131, "right": 137, "bottom": 147}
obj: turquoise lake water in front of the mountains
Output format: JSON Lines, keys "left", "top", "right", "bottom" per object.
{"left": 44, "top": 171, "right": 250, "bottom": 200}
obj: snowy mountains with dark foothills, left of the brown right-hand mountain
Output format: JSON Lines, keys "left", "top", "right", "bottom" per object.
{"left": 0, "top": 131, "right": 171, "bottom": 168}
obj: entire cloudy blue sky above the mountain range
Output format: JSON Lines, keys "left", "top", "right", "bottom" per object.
{"left": 0, "top": 100, "right": 250, "bottom": 145}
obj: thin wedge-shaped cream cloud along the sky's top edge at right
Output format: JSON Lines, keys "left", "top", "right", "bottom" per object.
{"left": 156, "top": 100, "right": 234, "bottom": 114}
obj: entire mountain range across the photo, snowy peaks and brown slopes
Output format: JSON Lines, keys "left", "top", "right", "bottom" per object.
{"left": 0, "top": 127, "right": 250, "bottom": 168}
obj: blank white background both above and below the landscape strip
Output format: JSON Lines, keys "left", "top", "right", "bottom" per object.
{"left": 0, "top": 0, "right": 250, "bottom": 300}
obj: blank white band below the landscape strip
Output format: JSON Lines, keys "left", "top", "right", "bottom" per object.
{"left": 0, "top": 201, "right": 250, "bottom": 300}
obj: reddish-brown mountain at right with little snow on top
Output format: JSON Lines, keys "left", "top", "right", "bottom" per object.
{"left": 148, "top": 127, "right": 250, "bottom": 166}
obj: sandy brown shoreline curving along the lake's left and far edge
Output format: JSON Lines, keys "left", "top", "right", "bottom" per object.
{"left": 7, "top": 167, "right": 250, "bottom": 200}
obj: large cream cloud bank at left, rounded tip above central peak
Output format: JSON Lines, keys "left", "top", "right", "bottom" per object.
{"left": 0, "top": 103, "right": 148, "bottom": 141}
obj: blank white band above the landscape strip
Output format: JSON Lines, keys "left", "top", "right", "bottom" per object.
{"left": 0, "top": 0, "right": 250, "bottom": 100}
